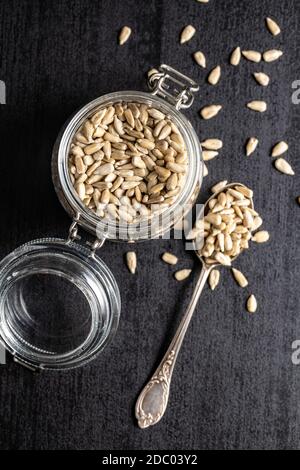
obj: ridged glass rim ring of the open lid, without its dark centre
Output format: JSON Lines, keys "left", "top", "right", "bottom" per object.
{"left": 0, "top": 238, "right": 121, "bottom": 370}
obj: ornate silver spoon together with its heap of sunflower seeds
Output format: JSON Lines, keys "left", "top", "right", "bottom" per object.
{"left": 135, "top": 181, "right": 267, "bottom": 428}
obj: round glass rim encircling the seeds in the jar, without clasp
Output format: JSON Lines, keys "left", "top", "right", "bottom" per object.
{"left": 52, "top": 90, "right": 203, "bottom": 241}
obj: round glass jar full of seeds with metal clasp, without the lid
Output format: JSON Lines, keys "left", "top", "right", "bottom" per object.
{"left": 52, "top": 65, "right": 203, "bottom": 241}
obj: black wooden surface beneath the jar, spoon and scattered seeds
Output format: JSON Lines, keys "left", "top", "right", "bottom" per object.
{"left": 0, "top": 0, "right": 300, "bottom": 450}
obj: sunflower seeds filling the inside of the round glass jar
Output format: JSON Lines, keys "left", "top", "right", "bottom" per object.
{"left": 69, "top": 102, "right": 188, "bottom": 223}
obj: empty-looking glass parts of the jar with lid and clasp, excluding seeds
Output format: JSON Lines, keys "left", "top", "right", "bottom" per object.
{"left": 0, "top": 65, "right": 203, "bottom": 370}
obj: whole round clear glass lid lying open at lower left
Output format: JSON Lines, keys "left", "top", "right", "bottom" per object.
{"left": 0, "top": 238, "right": 121, "bottom": 369}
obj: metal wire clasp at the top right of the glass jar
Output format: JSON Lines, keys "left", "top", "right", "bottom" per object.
{"left": 148, "top": 64, "right": 199, "bottom": 110}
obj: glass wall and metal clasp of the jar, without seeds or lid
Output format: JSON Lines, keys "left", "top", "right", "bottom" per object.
{"left": 52, "top": 65, "right": 203, "bottom": 242}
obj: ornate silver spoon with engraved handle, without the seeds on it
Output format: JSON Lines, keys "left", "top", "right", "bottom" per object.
{"left": 135, "top": 183, "right": 254, "bottom": 429}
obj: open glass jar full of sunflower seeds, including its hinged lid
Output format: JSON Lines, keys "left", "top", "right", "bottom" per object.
{"left": 0, "top": 65, "right": 203, "bottom": 370}
